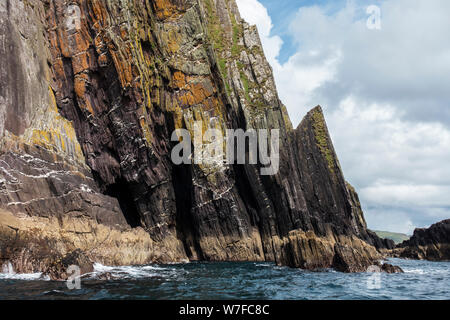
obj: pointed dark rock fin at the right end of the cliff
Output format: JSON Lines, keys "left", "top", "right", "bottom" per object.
{"left": 293, "top": 107, "right": 391, "bottom": 248}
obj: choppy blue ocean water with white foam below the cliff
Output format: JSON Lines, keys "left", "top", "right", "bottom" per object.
{"left": 0, "top": 259, "right": 450, "bottom": 300}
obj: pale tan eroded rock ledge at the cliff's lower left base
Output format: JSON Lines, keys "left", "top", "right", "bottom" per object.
{"left": 0, "top": 210, "right": 186, "bottom": 279}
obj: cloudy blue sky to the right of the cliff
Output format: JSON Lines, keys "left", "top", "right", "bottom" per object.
{"left": 237, "top": 0, "right": 450, "bottom": 233}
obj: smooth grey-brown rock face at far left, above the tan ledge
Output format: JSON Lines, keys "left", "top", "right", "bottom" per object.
{"left": 0, "top": 0, "right": 130, "bottom": 228}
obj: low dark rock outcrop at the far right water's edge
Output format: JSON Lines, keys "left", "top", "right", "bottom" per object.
{"left": 392, "top": 219, "right": 450, "bottom": 261}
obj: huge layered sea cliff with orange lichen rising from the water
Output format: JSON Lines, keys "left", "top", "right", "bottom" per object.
{"left": 0, "top": 0, "right": 390, "bottom": 278}
